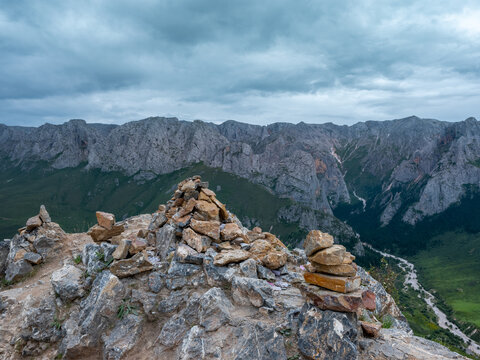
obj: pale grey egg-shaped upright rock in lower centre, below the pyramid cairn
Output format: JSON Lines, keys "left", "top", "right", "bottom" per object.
{"left": 198, "top": 288, "right": 233, "bottom": 332}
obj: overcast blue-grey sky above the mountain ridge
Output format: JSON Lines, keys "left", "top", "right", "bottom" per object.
{"left": 0, "top": 0, "right": 480, "bottom": 126}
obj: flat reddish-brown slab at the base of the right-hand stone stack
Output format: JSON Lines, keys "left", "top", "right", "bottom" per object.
{"left": 299, "top": 283, "right": 375, "bottom": 312}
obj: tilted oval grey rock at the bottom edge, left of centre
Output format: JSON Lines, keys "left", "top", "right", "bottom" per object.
{"left": 103, "top": 314, "right": 143, "bottom": 360}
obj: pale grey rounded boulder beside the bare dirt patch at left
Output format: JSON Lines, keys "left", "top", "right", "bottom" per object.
{"left": 50, "top": 265, "right": 84, "bottom": 301}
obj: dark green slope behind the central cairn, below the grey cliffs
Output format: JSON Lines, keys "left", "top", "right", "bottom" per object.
{"left": 0, "top": 163, "right": 304, "bottom": 242}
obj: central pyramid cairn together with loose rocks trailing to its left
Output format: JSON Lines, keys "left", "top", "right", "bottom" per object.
{"left": 83, "top": 176, "right": 288, "bottom": 278}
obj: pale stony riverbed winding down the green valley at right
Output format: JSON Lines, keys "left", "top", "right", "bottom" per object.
{"left": 362, "top": 243, "right": 480, "bottom": 356}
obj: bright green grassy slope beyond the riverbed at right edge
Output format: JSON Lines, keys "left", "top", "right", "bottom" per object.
{"left": 412, "top": 232, "right": 480, "bottom": 327}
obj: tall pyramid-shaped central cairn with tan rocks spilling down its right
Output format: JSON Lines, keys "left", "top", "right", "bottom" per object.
{"left": 147, "top": 176, "right": 287, "bottom": 269}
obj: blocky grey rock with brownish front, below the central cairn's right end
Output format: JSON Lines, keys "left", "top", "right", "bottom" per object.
{"left": 232, "top": 276, "right": 275, "bottom": 307}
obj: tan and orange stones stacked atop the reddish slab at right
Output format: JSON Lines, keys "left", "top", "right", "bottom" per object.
{"left": 304, "top": 230, "right": 360, "bottom": 293}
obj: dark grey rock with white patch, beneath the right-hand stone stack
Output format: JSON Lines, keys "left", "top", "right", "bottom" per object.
{"left": 298, "top": 304, "right": 358, "bottom": 360}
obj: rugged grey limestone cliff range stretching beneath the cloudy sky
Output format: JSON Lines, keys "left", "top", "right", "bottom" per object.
{"left": 0, "top": 117, "right": 480, "bottom": 225}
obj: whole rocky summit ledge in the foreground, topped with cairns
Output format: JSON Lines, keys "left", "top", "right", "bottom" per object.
{"left": 0, "top": 177, "right": 463, "bottom": 360}
